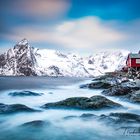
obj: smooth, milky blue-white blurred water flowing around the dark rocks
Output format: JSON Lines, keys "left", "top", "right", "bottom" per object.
{"left": 0, "top": 77, "right": 140, "bottom": 140}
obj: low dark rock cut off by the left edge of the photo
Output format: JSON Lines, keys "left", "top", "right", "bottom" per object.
{"left": 0, "top": 103, "right": 36, "bottom": 114}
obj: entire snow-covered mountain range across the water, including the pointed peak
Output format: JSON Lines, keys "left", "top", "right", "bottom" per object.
{"left": 0, "top": 39, "right": 128, "bottom": 77}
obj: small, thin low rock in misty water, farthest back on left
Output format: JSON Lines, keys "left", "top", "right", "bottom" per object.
{"left": 8, "top": 91, "right": 43, "bottom": 96}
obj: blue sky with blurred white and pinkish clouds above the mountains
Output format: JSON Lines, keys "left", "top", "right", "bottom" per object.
{"left": 0, "top": 0, "right": 140, "bottom": 55}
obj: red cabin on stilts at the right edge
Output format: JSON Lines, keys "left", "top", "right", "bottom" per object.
{"left": 126, "top": 53, "right": 140, "bottom": 71}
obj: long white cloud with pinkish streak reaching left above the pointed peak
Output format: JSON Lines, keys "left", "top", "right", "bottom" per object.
{"left": 3, "top": 17, "right": 127, "bottom": 51}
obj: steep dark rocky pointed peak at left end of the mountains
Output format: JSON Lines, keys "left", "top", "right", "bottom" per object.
{"left": 0, "top": 39, "right": 37, "bottom": 76}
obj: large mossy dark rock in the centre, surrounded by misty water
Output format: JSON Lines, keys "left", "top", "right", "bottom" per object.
{"left": 42, "top": 96, "right": 121, "bottom": 109}
